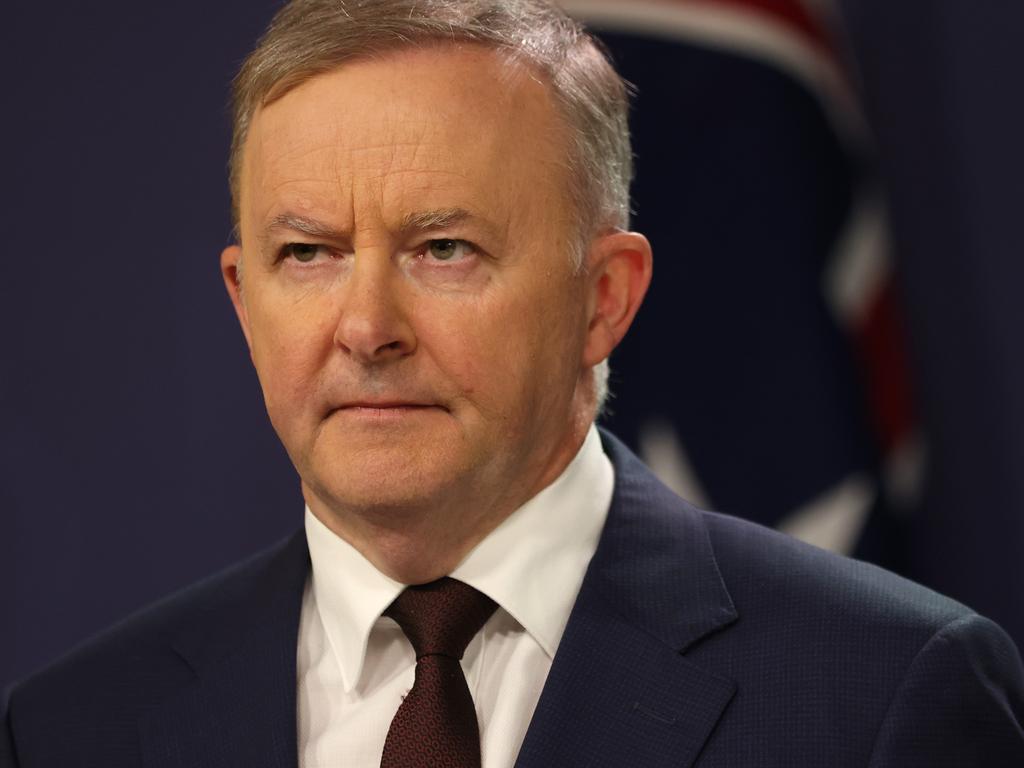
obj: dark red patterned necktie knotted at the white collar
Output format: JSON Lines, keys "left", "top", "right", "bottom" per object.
{"left": 381, "top": 577, "right": 498, "bottom": 768}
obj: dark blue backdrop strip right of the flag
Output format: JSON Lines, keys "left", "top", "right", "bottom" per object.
{"left": 843, "top": 0, "right": 1024, "bottom": 646}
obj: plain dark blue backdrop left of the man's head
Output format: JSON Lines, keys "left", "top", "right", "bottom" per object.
{"left": 0, "top": 0, "right": 301, "bottom": 684}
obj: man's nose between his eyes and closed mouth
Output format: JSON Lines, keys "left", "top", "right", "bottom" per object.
{"left": 334, "top": 254, "right": 416, "bottom": 366}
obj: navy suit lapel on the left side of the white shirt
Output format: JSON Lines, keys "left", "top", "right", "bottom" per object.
{"left": 139, "top": 534, "right": 308, "bottom": 768}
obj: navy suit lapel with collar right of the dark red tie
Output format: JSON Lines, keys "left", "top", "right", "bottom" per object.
{"left": 516, "top": 434, "right": 736, "bottom": 768}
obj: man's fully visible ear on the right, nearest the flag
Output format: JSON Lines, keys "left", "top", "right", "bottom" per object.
{"left": 583, "top": 231, "right": 652, "bottom": 367}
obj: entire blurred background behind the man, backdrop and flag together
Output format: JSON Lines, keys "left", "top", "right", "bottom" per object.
{"left": 0, "top": 0, "right": 1024, "bottom": 688}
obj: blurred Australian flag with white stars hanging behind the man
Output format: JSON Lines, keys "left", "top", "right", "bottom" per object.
{"left": 564, "top": 0, "right": 923, "bottom": 566}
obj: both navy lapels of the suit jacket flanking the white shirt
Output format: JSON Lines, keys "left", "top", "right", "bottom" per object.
{"left": 139, "top": 432, "right": 736, "bottom": 768}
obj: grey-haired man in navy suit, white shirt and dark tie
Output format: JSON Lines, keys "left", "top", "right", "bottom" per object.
{"left": 0, "top": 0, "right": 1024, "bottom": 768}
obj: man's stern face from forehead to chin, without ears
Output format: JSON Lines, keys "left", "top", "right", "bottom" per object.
{"left": 225, "top": 46, "right": 603, "bottom": 532}
